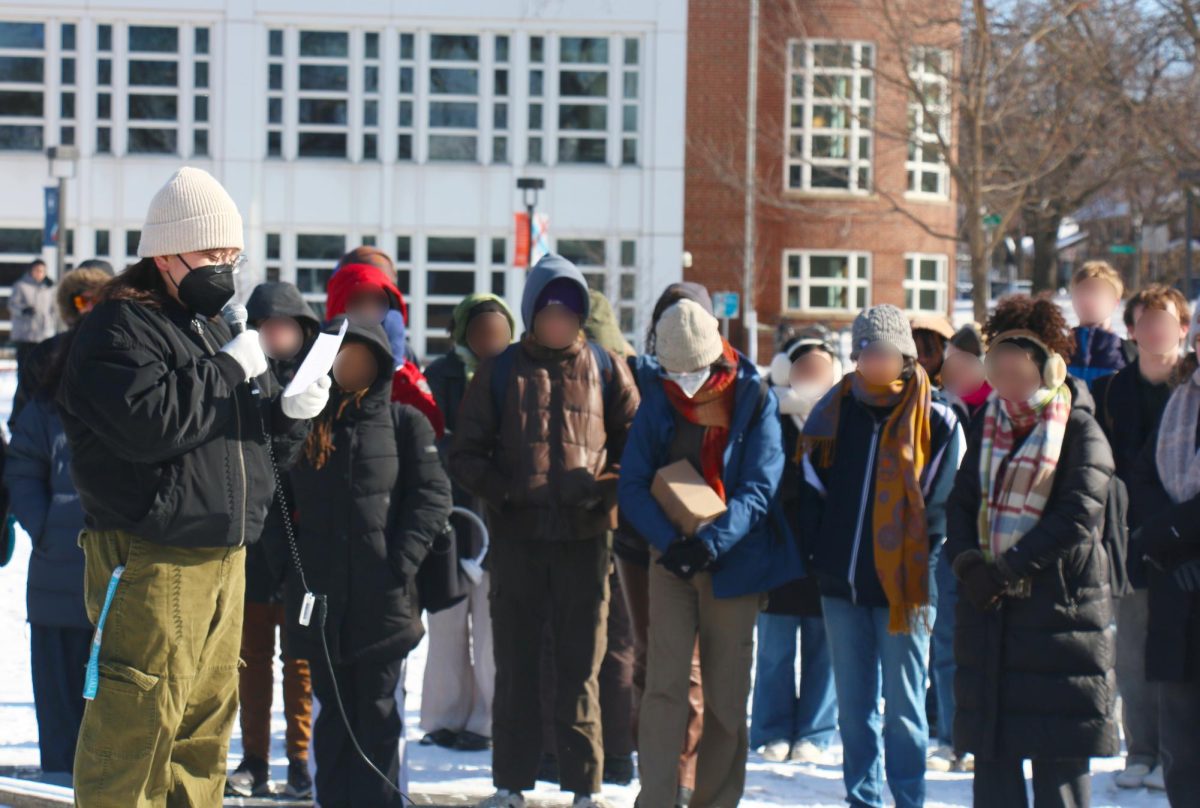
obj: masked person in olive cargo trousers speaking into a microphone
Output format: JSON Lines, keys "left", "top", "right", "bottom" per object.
{"left": 59, "top": 168, "right": 329, "bottom": 808}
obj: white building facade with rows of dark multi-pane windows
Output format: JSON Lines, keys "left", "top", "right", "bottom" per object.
{"left": 0, "top": 0, "right": 686, "bottom": 355}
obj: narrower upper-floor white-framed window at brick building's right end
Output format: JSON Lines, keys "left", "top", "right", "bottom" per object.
{"left": 905, "top": 46, "right": 954, "bottom": 199}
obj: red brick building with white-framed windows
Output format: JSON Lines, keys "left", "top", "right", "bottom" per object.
{"left": 684, "top": 0, "right": 958, "bottom": 361}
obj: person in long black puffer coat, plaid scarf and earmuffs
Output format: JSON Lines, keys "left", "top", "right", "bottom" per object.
{"left": 946, "top": 295, "right": 1120, "bottom": 808}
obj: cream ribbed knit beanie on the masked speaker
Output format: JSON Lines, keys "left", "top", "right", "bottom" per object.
{"left": 138, "top": 167, "right": 245, "bottom": 258}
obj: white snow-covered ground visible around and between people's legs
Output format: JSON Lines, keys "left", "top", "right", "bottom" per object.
{"left": 0, "top": 363, "right": 1168, "bottom": 808}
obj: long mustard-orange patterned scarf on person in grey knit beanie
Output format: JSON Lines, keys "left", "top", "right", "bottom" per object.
{"left": 800, "top": 365, "right": 932, "bottom": 634}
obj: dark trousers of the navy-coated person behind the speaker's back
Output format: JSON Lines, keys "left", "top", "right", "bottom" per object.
{"left": 29, "top": 623, "right": 91, "bottom": 773}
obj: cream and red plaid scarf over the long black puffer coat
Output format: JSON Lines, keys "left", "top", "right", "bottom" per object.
{"left": 979, "top": 384, "right": 1070, "bottom": 558}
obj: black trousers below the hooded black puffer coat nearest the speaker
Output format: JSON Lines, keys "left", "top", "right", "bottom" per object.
{"left": 312, "top": 659, "right": 404, "bottom": 808}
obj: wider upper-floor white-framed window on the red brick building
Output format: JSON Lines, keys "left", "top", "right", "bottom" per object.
{"left": 782, "top": 38, "right": 877, "bottom": 194}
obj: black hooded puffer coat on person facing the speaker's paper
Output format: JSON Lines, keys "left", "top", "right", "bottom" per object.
{"left": 287, "top": 319, "right": 450, "bottom": 664}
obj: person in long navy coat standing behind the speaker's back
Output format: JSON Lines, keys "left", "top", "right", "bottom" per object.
{"left": 4, "top": 269, "right": 110, "bottom": 782}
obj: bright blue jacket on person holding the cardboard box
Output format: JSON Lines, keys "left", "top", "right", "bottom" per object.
{"left": 619, "top": 355, "right": 804, "bottom": 598}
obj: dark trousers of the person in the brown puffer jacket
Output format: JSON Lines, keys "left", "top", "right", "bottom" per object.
{"left": 488, "top": 535, "right": 611, "bottom": 794}
